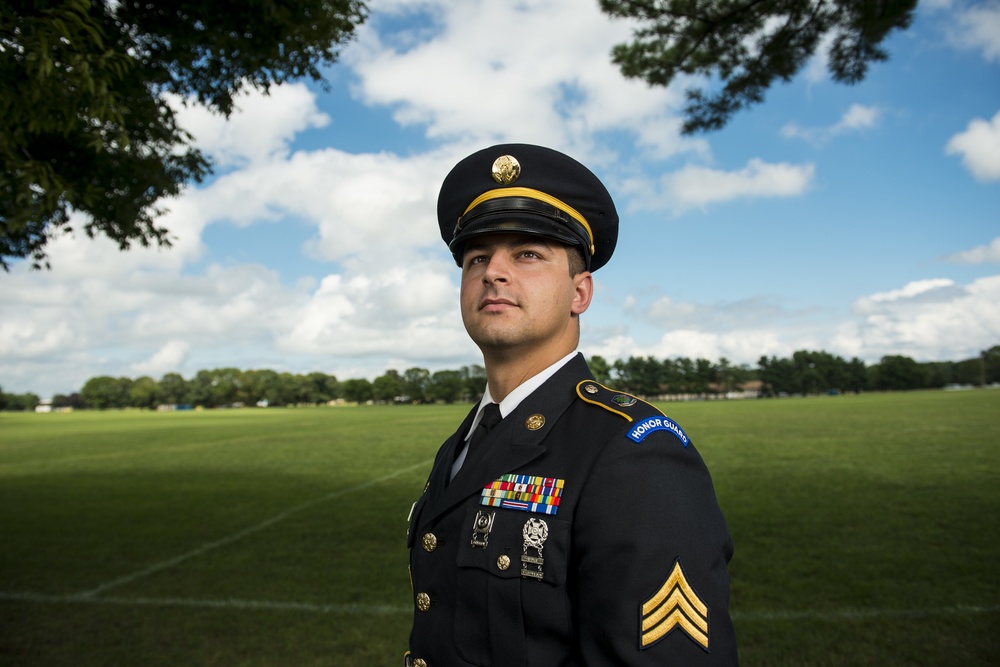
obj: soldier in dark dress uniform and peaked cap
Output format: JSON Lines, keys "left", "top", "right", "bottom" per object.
{"left": 405, "top": 144, "right": 737, "bottom": 667}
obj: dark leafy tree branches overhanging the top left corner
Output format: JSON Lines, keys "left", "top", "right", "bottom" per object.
{"left": 0, "top": 0, "right": 367, "bottom": 270}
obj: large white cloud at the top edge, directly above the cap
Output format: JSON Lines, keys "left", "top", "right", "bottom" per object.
{"left": 345, "top": 0, "right": 706, "bottom": 162}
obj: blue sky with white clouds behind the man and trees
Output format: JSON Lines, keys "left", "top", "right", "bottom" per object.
{"left": 0, "top": 0, "right": 1000, "bottom": 397}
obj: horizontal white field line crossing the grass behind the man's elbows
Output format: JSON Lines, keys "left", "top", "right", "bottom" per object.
{"left": 0, "top": 592, "right": 1000, "bottom": 623}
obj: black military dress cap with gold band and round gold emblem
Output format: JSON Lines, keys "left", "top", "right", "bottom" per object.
{"left": 438, "top": 144, "right": 618, "bottom": 271}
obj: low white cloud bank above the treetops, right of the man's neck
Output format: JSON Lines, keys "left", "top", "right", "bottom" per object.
{"left": 583, "top": 275, "right": 1000, "bottom": 366}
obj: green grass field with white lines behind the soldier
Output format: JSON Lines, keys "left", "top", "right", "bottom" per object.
{"left": 0, "top": 390, "right": 1000, "bottom": 667}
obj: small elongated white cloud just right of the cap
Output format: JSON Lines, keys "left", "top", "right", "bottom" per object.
{"left": 652, "top": 158, "right": 816, "bottom": 212}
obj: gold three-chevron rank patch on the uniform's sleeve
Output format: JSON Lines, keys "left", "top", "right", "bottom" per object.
{"left": 639, "top": 560, "right": 708, "bottom": 651}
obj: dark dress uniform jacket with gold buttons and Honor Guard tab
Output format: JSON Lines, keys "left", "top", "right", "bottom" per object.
{"left": 406, "top": 355, "right": 737, "bottom": 667}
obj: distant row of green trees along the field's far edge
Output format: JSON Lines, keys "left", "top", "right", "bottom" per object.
{"left": 0, "top": 345, "right": 1000, "bottom": 411}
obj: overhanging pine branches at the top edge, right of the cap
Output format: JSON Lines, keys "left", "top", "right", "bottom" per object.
{"left": 600, "top": 0, "right": 917, "bottom": 134}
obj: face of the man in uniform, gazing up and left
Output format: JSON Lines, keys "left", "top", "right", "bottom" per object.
{"left": 461, "top": 234, "right": 593, "bottom": 354}
